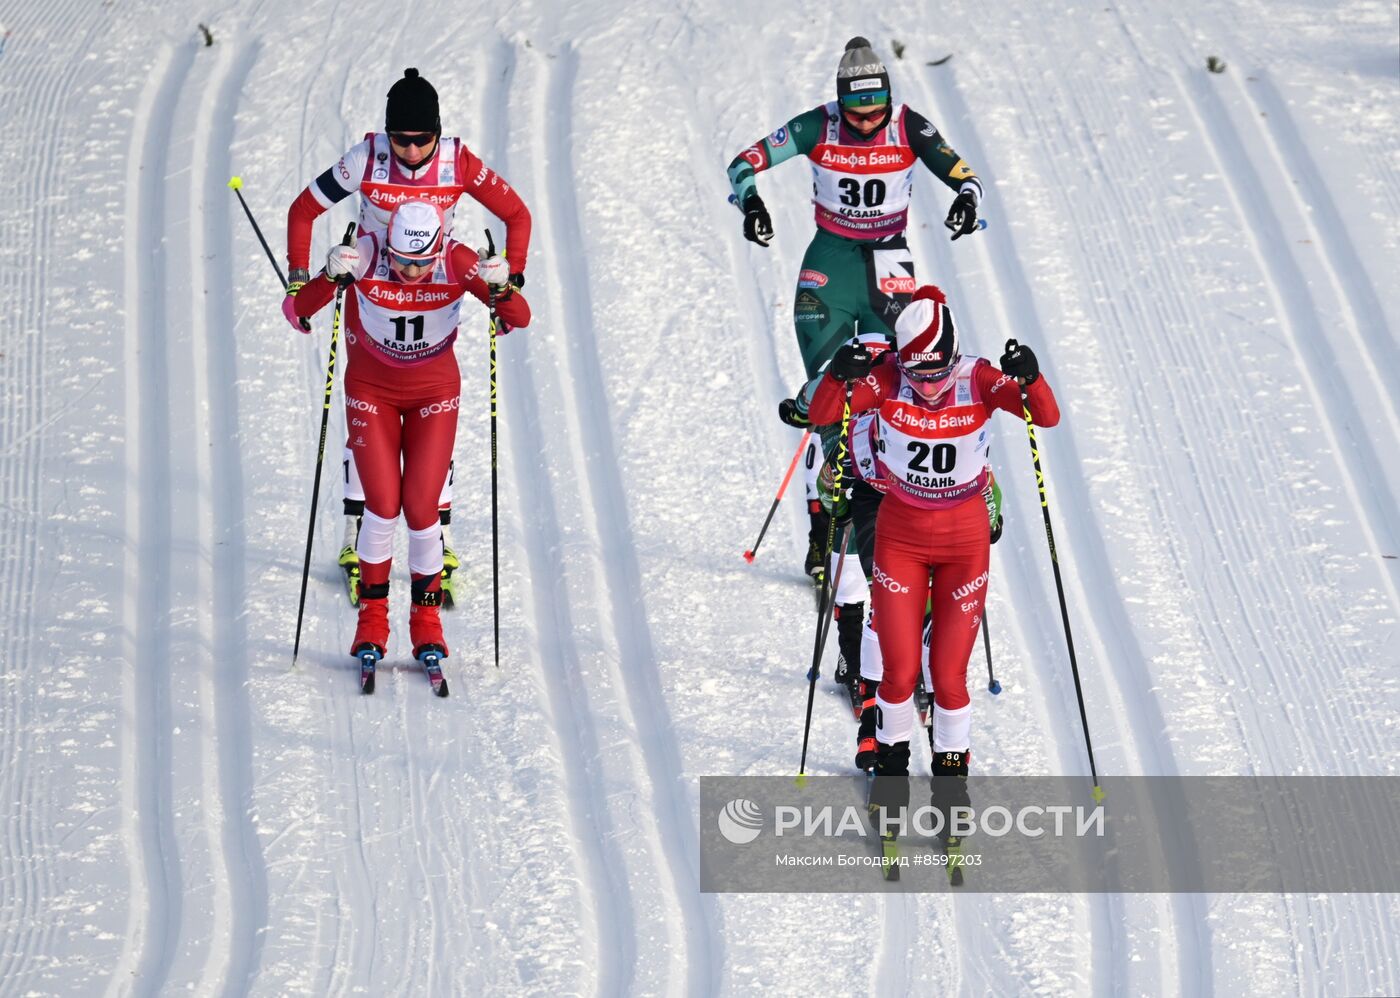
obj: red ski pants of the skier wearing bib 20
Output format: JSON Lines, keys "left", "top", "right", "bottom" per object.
{"left": 871, "top": 496, "right": 991, "bottom": 710}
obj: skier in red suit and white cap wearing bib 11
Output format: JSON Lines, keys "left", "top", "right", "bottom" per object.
{"left": 293, "top": 200, "right": 531, "bottom": 669}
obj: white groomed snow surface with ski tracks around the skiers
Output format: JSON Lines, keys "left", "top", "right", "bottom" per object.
{"left": 0, "top": 0, "right": 1400, "bottom": 995}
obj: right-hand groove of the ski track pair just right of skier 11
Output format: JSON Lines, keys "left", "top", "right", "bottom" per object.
{"left": 539, "top": 40, "right": 722, "bottom": 995}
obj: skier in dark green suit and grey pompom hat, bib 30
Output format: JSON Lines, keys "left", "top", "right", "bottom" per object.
{"left": 729, "top": 36, "right": 983, "bottom": 577}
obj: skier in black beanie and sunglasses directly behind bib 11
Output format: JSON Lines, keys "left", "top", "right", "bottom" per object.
{"left": 283, "top": 69, "right": 531, "bottom": 599}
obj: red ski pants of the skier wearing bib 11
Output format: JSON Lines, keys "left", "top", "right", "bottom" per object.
{"left": 346, "top": 364, "right": 462, "bottom": 530}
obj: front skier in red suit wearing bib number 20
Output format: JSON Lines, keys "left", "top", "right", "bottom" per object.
{"left": 809, "top": 286, "right": 1060, "bottom": 823}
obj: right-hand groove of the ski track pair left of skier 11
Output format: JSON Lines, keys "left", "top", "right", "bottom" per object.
{"left": 190, "top": 38, "right": 267, "bottom": 995}
